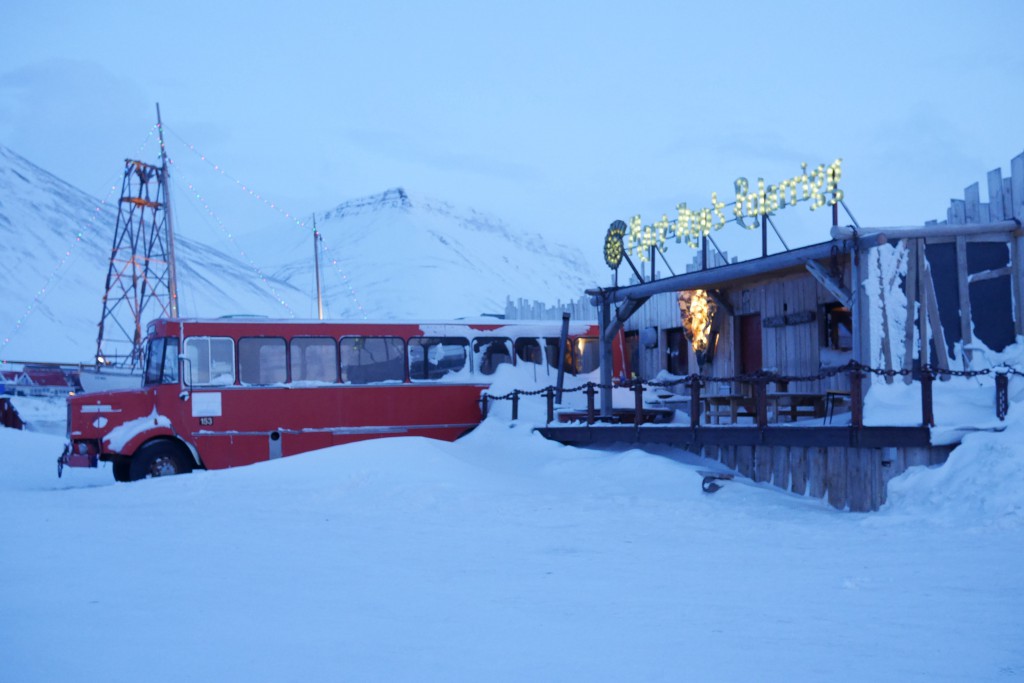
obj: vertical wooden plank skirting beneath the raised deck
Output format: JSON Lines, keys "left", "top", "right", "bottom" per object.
{"left": 700, "top": 445, "right": 953, "bottom": 512}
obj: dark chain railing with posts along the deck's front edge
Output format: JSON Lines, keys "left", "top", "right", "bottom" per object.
{"left": 480, "top": 360, "right": 1024, "bottom": 429}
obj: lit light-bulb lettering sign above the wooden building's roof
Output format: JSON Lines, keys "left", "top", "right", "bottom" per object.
{"left": 618, "top": 159, "right": 843, "bottom": 266}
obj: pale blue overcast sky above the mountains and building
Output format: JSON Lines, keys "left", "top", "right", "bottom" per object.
{"left": 0, "top": 0, "right": 1024, "bottom": 274}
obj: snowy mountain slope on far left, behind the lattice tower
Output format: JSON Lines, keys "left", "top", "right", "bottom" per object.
{"left": 0, "top": 146, "right": 309, "bottom": 362}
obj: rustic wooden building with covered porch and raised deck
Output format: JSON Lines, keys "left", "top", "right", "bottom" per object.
{"left": 544, "top": 155, "right": 1024, "bottom": 510}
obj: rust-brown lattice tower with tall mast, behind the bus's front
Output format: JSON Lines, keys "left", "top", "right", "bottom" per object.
{"left": 95, "top": 105, "right": 178, "bottom": 371}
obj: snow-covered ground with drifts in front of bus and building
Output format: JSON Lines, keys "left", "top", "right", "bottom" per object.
{"left": 0, "top": 378, "right": 1024, "bottom": 683}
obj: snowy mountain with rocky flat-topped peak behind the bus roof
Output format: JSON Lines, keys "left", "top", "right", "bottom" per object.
{"left": 236, "top": 187, "right": 596, "bottom": 318}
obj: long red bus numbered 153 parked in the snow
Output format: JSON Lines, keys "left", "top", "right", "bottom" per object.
{"left": 59, "top": 317, "right": 599, "bottom": 481}
